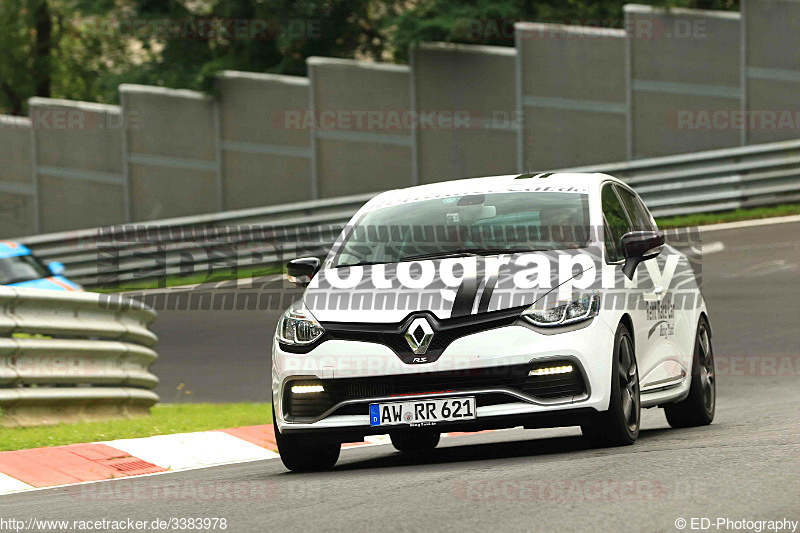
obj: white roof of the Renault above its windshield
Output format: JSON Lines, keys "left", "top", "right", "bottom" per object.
{"left": 367, "top": 172, "right": 621, "bottom": 208}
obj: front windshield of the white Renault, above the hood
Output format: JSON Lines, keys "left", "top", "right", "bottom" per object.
{"left": 332, "top": 191, "right": 589, "bottom": 267}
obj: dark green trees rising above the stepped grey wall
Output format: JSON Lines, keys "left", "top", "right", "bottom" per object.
{"left": 0, "top": 0, "right": 738, "bottom": 114}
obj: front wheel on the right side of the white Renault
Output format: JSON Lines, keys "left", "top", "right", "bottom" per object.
{"left": 581, "top": 324, "right": 641, "bottom": 447}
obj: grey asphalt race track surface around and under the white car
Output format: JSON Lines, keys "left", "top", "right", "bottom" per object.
{"left": 0, "top": 223, "right": 800, "bottom": 533}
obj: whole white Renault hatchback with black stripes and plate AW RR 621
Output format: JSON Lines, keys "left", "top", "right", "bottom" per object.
{"left": 272, "top": 173, "right": 715, "bottom": 470}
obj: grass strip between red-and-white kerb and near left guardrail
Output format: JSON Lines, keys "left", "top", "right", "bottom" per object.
{"left": 0, "top": 403, "right": 272, "bottom": 451}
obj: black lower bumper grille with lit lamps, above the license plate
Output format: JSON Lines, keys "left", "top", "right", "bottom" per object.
{"left": 284, "top": 360, "right": 586, "bottom": 419}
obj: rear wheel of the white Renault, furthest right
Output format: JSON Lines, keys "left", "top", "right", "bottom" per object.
{"left": 664, "top": 318, "right": 717, "bottom": 428}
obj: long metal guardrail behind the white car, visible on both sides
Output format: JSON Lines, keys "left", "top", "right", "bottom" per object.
{"left": 12, "top": 140, "right": 800, "bottom": 286}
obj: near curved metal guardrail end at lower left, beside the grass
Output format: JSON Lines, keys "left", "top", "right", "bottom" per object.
{"left": 0, "top": 286, "right": 158, "bottom": 426}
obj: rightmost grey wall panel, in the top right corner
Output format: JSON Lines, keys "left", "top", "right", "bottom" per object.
{"left": 742, "top": 0, "right": 800, "bottom": 144}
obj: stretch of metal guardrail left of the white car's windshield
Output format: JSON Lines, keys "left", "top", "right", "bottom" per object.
{"left": 18, "top": 193, "right": 377, "bottom": 286}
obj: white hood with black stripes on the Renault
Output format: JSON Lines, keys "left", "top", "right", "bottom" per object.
{"left": 303, "top": 250, "right": 595, "bottom": 323}
